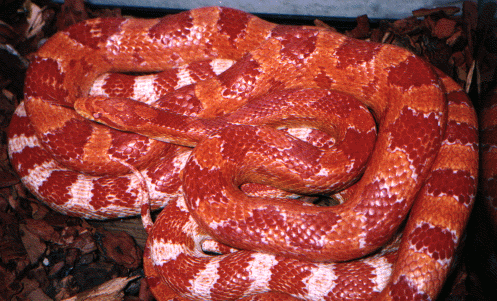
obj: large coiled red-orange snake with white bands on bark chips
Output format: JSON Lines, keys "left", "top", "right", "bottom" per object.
{"left": 9, "top": 7, "right": 478, "bottom": 300}
